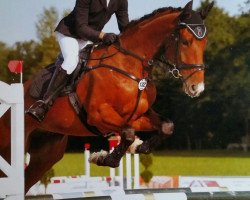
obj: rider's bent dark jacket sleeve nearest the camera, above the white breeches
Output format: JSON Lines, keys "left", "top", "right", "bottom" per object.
{"left": 75, "top": 0, "right": 101, "bottom": 42}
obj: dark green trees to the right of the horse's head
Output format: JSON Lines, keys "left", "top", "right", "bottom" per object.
{"left": 150, "top": 0, "right": 250, "bottom": 149}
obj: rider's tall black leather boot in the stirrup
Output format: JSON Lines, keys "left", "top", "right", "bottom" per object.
{"left": 26, "top": 67, "right": 69, "bottom": 122}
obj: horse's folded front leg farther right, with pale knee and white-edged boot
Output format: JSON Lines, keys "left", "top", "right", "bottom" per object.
{"left": 129, "top": 109, "right": 174, "bottom": 154}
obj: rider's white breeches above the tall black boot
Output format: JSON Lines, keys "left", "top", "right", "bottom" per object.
{"left": 56, "top": 32, "right": 92, "bottom": 74}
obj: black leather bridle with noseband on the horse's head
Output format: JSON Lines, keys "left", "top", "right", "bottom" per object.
{"left": 158, "top": 22, "right": 207, "bottom": 82}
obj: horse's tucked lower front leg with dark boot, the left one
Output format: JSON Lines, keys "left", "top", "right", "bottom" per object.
{"left": 89, "top": 128, "right": 135, "bottom": 168}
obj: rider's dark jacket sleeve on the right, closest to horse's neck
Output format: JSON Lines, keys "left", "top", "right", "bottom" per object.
{"left": 115, "top": 0, "right": 129, "bottom": 32}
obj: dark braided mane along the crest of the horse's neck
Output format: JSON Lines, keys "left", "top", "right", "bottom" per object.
{"left": 123, "top": 7, "right": 182, "bottom": 31}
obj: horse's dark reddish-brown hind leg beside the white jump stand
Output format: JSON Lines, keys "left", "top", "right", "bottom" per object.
{"left": 25, "top": 133, "right": 68, "bottom": 192}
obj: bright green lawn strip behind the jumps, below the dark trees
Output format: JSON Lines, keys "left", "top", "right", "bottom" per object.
{"left": 53, "top": 151, "right": 250, "bottom": 176}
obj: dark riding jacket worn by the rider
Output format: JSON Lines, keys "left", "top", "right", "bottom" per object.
{"left": 55, "top": 0, "right": 129, "bottom": 42}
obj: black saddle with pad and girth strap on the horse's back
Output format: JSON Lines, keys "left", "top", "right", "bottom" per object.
{"left": 29, "top": 44, "right": 102, "bottom": 136}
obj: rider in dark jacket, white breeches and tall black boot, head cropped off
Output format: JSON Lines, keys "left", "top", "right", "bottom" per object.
{"left": 27, "top": 0, "right": 129, "bottom": 122}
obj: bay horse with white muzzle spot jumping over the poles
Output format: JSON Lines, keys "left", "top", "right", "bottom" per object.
{"left": 0, "top": 1, "right": 213, "bottom": 192}
